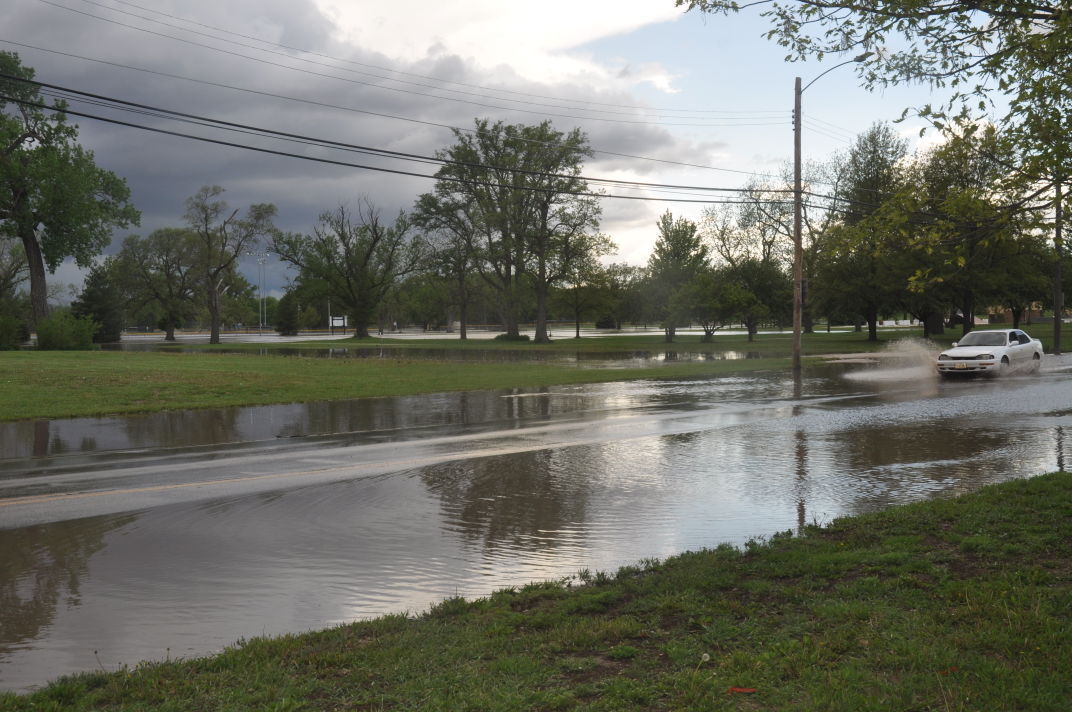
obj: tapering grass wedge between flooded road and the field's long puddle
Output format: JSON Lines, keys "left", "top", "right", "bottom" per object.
{"left": 0, "top": 351, "right": 788, "bottom": 420}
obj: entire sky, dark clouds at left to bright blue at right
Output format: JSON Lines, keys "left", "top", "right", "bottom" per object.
{"left": 0, "top": 0, "right": 947, "bottom": 296}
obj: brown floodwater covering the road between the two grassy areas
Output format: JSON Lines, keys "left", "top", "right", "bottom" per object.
{"left": 0, "top": 347, "right": 1072, "bottom": 689}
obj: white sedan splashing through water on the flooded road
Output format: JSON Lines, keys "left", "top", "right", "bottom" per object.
{"left": 938, "top": 329, "right": 1042, "bottom": 375}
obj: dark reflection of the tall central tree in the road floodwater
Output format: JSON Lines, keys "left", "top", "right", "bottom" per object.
{"left": 421, "top": 448, "right": 599, "bottom": 550}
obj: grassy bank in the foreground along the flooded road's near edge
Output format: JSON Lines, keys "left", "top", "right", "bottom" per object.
{"left": 6, "top": 473, "right": 1072, "bottom": 712}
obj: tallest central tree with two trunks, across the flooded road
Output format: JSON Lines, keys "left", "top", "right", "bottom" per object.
{"left": 426, "top": 119, "right": 608, "bottom": 341}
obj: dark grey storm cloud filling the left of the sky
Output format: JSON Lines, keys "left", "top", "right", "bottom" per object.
{"left": 8, "top": 0, "right": 717, "bottom": 287}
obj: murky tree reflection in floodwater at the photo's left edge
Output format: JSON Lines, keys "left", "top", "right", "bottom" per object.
{"left": 0, "top": 515, "right": 137, "bottom": 658}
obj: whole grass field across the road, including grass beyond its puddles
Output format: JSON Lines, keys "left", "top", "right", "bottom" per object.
{"left": 0, "top": 331, "right": 926, "bottom": 420}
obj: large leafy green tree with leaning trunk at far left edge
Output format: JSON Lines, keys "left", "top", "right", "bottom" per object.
{"left": 0, "top": 51, "right": 139, "bottom": 322}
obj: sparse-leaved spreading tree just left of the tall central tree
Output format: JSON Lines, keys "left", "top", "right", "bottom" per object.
{"left": 272, "top": 198, "right": 425, "bottom": 338}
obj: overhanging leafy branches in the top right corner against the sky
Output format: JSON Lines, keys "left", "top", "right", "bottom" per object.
{"left": 675, "top": 0, "right": 1072, "bottom": 151}
